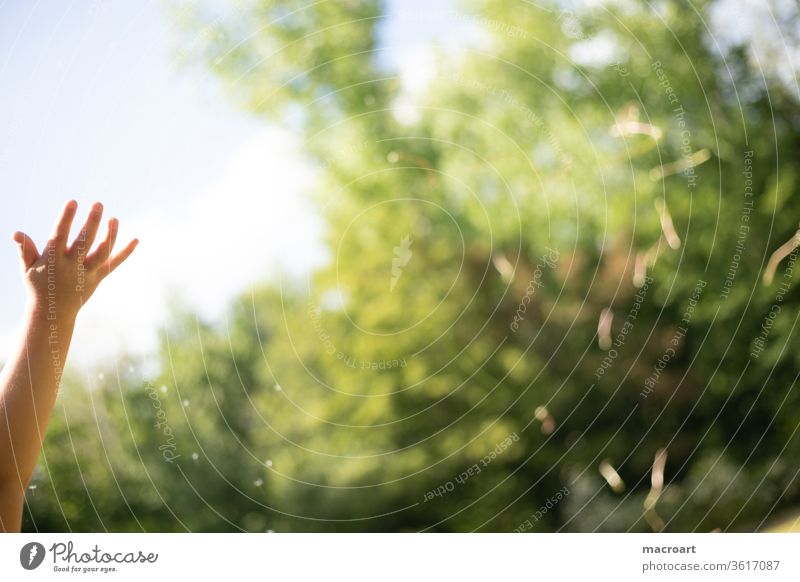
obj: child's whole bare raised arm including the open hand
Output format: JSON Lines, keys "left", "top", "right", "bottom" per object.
{"left": 0, "top": 200, "right": 139, "bottom": 532}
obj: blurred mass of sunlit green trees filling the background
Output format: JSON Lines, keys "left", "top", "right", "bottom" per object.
{"left": 21, "top": 0, "right": 800, "bottom": 531}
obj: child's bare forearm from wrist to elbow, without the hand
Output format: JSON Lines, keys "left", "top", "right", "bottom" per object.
{"left": 0, "top": 304, "right": 76, "bottom": 491}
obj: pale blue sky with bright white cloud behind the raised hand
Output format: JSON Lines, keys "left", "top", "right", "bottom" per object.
{"left": 0, "top": 0, "right": 459, "bottom": 362}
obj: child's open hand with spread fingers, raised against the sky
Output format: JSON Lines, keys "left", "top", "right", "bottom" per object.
{"left": 14, "top": 200, "right": 139, "bottom": 318}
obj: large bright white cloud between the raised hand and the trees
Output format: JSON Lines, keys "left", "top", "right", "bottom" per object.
{"left": 71, "top": 129, "right": 326, "bottom": 363}
